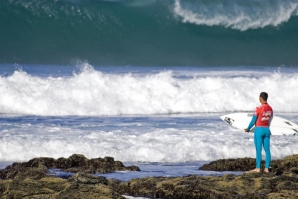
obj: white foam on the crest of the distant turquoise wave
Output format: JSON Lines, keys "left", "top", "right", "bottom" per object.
{"left": 173, "top": 0, "right": 298, "bottom": 31}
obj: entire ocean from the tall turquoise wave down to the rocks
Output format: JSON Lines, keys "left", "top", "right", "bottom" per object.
{"left": 0, "top": 0, "right": 298, "bottom": 180}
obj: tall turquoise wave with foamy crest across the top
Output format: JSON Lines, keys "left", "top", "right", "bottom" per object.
{"left": 0, "top": 0, "right": 298, "bottom": 66}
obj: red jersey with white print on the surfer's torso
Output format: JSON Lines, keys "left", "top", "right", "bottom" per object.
{"left": 254, "top": 103, "right": 273, "bottom": 126}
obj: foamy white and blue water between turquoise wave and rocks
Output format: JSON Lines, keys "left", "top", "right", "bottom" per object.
{"left": 0, "top": 63, "right": 298, "bottom": 180}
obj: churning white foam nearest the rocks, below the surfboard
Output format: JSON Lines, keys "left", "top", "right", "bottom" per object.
{"left": 0, "top": 115, "right": 298, "bottom": 162}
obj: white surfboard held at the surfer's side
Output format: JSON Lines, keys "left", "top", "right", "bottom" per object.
{"left": 220, "top": 113, "right": 298, "bottom": 135}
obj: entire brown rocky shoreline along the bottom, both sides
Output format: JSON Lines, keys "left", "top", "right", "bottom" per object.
{"left": 0, "top": 154, "right": 298, "bottom": 199}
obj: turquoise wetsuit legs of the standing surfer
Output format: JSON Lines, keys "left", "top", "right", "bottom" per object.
{"left": 254, "top": 126, "right": 271, "bottom": 168}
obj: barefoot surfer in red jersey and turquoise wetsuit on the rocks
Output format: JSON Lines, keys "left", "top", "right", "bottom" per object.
{"left": 244, "top": 92, "right": 273, "bottom": 173}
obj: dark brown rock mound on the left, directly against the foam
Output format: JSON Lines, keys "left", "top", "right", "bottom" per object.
{"left": 0, "top": 154, "right": 140, "bottom": 179}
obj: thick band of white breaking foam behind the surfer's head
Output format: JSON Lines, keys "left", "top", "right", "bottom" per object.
{"left": 0, "top": 65, "right": 298, "bottom": 116}
